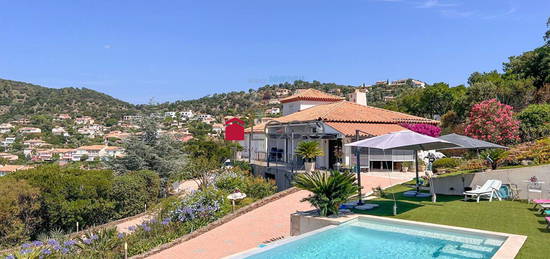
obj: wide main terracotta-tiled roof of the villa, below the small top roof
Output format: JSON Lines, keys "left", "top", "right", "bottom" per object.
{"left": 275, "top": 101, "right": 439, "bottom": 124}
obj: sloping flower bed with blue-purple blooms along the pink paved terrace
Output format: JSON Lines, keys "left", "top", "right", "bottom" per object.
{"left": 0, "top": 162, "right": 276, "bottom": 258}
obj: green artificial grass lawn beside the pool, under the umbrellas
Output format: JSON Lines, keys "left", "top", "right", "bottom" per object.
{"left": 354, "top": 185, "right": 550, "bottom": 258}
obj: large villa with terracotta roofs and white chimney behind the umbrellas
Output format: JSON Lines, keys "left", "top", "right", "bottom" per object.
{"left": 241, "top": 89, "right": 439, "bottom": 173}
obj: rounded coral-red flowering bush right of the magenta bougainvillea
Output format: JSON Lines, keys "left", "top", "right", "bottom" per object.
{"left": 464, "top": 99, "right": 519, "bottom": 144}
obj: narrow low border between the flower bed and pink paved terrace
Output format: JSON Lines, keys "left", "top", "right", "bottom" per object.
{"left": 130, "top": 187, "right": 299, "bottom": 259}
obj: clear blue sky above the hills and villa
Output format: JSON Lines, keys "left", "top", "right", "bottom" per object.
{"left": 0, "top": 0, "right": 550, "bottom": 103}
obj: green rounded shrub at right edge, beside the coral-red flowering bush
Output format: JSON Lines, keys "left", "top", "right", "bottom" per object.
{"left": 517, "top": 103, "right": 550, "bottom": 141}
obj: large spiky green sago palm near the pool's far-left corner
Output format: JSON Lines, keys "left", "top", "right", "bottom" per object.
{"left": 295, "top": 171, "right": 357, "bottom": 216}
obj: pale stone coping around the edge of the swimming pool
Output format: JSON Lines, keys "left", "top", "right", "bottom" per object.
{"left": 223, "top": 214, "right": 527, "bottom": 259}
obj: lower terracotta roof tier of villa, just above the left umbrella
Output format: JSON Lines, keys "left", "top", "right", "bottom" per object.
{"left": 326, "top": 122, "right": 406, "bottom": 136}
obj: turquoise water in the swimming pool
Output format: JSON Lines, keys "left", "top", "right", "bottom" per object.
{"left": 246, "top": 219, "right": 505, "bottom": 259}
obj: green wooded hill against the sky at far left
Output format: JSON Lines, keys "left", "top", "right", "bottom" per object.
{"left": 0, "top": 79, "right": 136, "bottom": 122}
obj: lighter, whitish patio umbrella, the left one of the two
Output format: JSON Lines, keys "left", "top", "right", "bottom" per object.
{"left": 346, "top": 130, "right": 459, "bottom": 195}
